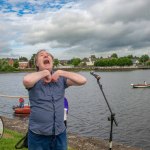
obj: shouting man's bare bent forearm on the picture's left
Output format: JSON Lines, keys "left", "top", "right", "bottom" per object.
{"left": 23, "top": 70, "right": 50, "bottom": 88}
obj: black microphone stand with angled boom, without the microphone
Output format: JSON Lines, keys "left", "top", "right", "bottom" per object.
{"left": 96, "top": 78, "right": 118, "bottom": 150}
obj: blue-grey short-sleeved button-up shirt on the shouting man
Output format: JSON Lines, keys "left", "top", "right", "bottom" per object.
{"left": 29, "top": 77, "right": 67, "bottom": 135}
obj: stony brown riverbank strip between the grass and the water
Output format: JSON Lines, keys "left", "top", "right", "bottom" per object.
{"left": 0, "top": 117, "right": 142, "bottom": 150}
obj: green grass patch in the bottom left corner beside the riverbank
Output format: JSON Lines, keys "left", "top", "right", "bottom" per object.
{"left": 0, "top": 129, "right": 74, "bottom": 150}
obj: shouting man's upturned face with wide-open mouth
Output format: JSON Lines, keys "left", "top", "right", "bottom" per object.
{"left": 36, "top": 50, "right": 53, "bottom": 71}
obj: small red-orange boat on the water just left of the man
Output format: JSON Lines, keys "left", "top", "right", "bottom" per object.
{"left": 13, "top": 105, "right": 30, "bottom": 114}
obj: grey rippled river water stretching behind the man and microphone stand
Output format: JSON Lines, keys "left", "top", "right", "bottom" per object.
{"left": 0, "top": 70, "right": 150, "bottom": 150}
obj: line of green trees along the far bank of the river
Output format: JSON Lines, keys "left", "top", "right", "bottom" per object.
{"left": 0, "top": 53, "right": 150, "bottom": 72}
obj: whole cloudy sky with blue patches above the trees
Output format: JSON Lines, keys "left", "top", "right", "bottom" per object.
{"left": 0, "top": 0, "right": 150, "bottom": 59}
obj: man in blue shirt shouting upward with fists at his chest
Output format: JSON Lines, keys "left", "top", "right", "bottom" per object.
{"left": 23, "top": 50, "right": 86, "bottom": 150}
